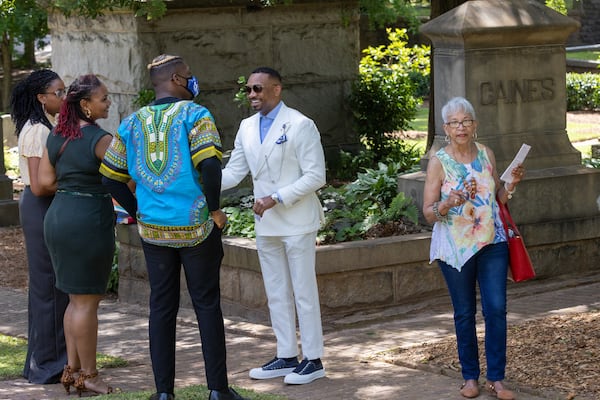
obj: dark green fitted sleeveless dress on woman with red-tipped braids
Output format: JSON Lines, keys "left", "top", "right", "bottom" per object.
{"left": 44, "top": 125, "right": 115, "bottom": 294}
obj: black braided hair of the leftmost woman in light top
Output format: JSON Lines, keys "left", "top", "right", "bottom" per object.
{"left": 10, "top": 69, "right": 60, "bottom": 136}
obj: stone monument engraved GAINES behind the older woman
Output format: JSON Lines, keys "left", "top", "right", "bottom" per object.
{"left": 399, "top": 0, "right": 600, "bottom": 276}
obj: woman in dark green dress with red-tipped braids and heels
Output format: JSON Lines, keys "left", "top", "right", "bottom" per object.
{"left": 39, "top": 75, "right": 115, "bottom": 394}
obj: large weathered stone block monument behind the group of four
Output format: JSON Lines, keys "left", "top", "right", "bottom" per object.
{"left": 48, "top": 0, "right": 360, "bottom": 158}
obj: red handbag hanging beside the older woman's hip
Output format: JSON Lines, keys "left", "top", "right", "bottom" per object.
{"left": 497, "top": 200, "right": 535, "bottom": 282}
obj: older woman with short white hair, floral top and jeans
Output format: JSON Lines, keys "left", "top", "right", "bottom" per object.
{"left": 423, "top": 97, "right": 525, "bottom": 399}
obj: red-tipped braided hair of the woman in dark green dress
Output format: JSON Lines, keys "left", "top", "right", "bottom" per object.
{"left": 55, "top": 74, "right": 102, "bottom": 140}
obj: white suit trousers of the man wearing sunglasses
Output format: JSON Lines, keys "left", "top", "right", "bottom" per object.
{"left": 256, "top": 231, "right": 323, "bottom": 360}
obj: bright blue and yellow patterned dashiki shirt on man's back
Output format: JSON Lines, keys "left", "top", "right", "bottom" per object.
{"left": 100, "top": 99, "right": 222, "bottom": 247}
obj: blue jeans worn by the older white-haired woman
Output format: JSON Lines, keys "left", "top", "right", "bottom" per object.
{"left": 438, "top": 242, "right": 508, "bottom": 382}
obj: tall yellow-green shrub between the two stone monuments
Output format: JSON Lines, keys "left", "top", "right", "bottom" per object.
{"left": 349, "top": 29, "right": 430, "bottom": 161}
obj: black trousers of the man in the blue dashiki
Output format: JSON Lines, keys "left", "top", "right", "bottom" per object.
{"left": 142, "top": 227, "right": 228, "bottom": 393}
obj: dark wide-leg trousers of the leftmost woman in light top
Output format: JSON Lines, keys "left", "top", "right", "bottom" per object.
{"left": 19, "top": 186, "right": 69, "bottom": 384}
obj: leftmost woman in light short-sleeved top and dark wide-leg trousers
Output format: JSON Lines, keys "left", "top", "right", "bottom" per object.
{"left": 10, "top": 69, "right": 69, "bottom": 384}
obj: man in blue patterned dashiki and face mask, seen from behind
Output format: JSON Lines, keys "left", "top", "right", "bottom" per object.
{"left": 101, "top": 55, "right": 243, "bottom": 400}
